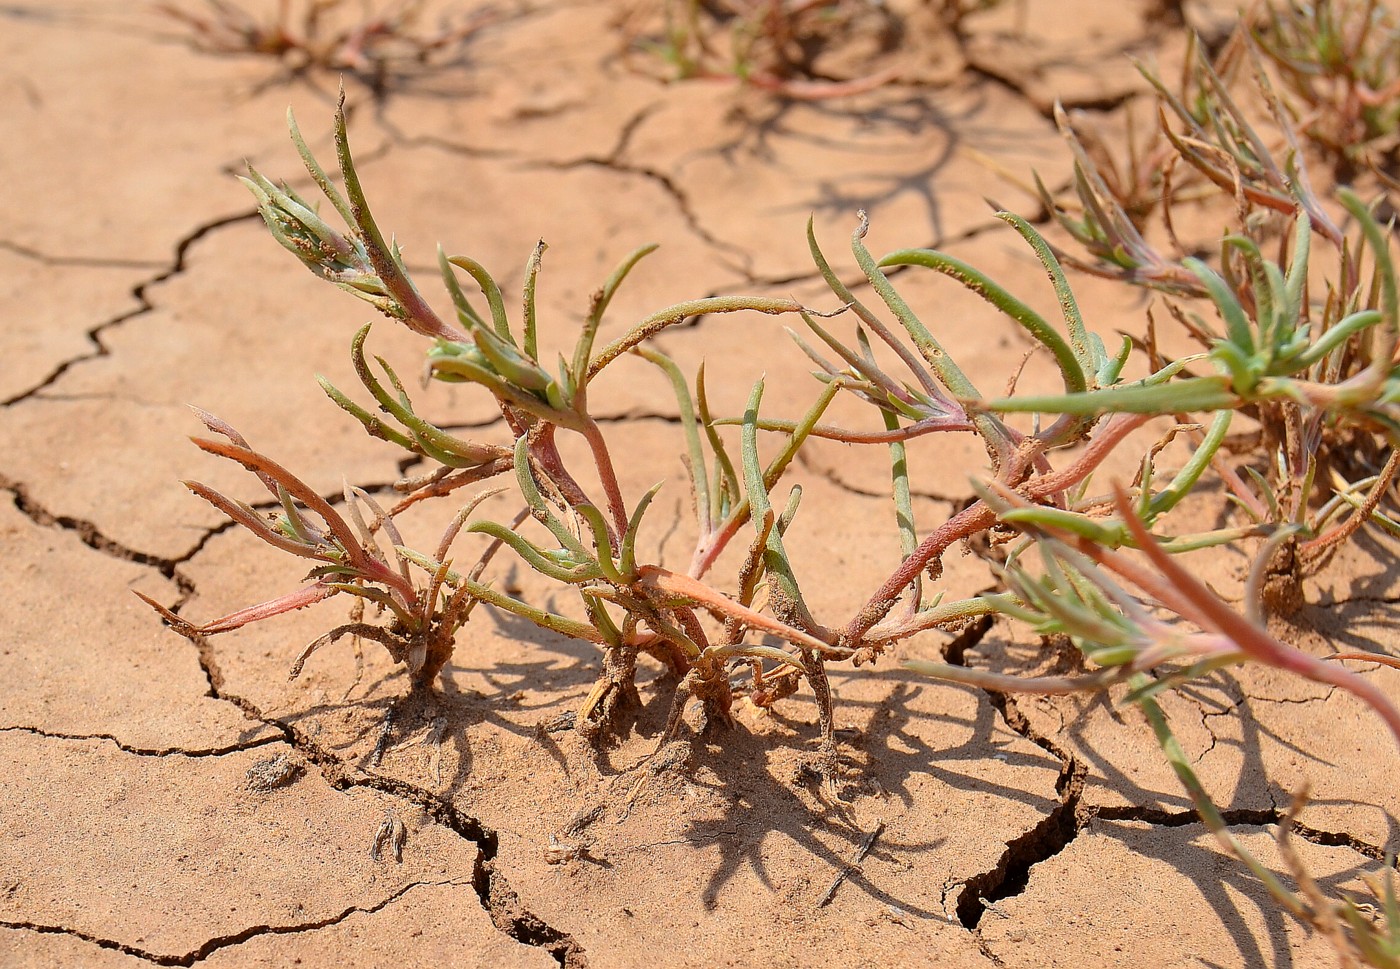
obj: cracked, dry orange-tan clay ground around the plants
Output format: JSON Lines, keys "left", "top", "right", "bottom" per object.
{"left": 0, "top": 0, "right": 1400, "bottom": 969}
